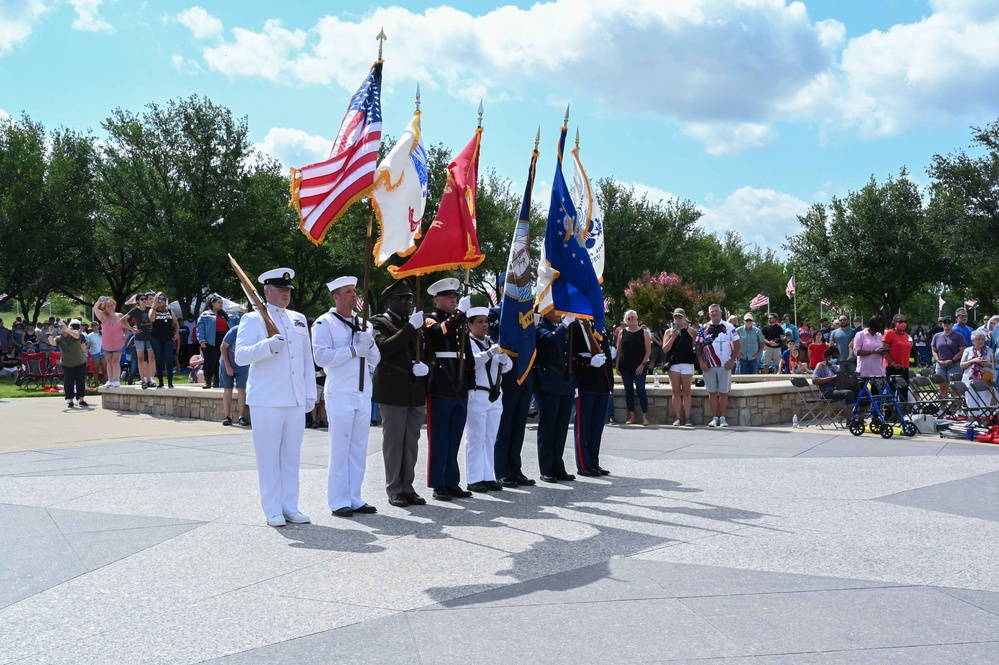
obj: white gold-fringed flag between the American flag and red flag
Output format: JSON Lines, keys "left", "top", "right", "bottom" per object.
{"left": 371, "top": 111, "right": 429, "bottom": 266}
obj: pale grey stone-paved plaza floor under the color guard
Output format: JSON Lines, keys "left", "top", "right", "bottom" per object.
{"left": 0, "top": 400, "right": 999, "bottom": 665}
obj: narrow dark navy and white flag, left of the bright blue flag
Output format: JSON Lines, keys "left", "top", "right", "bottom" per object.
{"left": 497, "top": 145, "right": 538, "bottom": 384}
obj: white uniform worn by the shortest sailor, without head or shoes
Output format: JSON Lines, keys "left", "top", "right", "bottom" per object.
{"left": 465, "top": 332, "right": 513, "bottom": 484}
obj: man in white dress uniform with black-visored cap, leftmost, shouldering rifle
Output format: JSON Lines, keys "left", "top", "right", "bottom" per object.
{"left": 235, "top": 268, "right": 316, "bottom": 527}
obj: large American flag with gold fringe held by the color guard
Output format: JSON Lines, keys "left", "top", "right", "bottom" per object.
{"left": 291, "top": 60, "right": 382, "bottom": 245}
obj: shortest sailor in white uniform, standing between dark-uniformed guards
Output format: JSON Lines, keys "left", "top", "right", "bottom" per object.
{"left": 465, "top": 307, "right": 513, "bottom": 492}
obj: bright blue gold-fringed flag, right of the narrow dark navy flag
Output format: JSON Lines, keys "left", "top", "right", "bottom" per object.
{"left": 538, "top": 127, "right": 604, "bottom": 335}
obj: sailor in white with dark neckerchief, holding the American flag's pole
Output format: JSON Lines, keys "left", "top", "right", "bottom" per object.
{"left": 312, "top": 277, "right": 381, "bottom": 517}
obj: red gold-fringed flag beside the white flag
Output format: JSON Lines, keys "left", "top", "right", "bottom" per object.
{"left": 389, "top": 127, "right": 486, "bottom": 279}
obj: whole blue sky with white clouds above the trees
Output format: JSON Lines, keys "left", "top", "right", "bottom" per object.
{"left": 0, "top": 0, "right": 999, "bottom": 250}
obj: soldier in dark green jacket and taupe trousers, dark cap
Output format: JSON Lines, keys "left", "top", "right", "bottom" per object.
{"left": 371, "top": 279, "right": 430, "bottom": 508}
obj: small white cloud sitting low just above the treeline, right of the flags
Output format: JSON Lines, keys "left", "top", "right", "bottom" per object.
{"left": 698, "top": 187, "right": 810, "bottom": 255}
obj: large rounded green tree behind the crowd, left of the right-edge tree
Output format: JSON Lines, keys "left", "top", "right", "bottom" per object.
{"left": 784, "top": 168, "right": 954, "bottom": 314}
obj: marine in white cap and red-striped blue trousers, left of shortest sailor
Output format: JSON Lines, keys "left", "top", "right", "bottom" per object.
{"left": 423, "top": 278, "right": 475, "bottom": 501}
